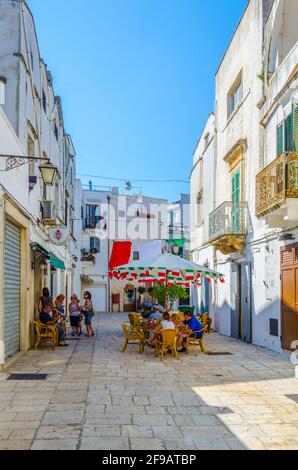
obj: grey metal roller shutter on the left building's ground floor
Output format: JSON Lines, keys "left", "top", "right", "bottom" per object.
{"left": 4, "top": 220, "right": 21, "bottom": 358}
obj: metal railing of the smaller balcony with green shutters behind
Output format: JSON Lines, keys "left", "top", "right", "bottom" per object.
{"left": 209, "top": 202, "right": 249, "bottom": 242}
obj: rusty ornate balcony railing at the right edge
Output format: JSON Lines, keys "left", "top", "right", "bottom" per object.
{"left": 256, "top": 152, "right": 298, "bottom": 217}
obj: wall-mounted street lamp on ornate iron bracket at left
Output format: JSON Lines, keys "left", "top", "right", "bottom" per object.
{"left": 0, "top": 155, "right": 58, "bottom": 186}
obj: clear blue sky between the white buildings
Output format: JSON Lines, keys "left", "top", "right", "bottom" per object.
{"left": 28, "top": 0, "right": 247, "bottom": 201}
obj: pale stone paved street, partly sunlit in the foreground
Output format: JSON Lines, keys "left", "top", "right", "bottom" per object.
{"left": 0, "top": 314, "right": 298, "bottom": 450}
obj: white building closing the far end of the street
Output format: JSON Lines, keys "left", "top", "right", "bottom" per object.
{"left": 81, "top": 183, "right": 168, "bottom": 312}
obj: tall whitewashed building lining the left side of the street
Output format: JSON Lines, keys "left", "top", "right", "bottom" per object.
{"left": 0, "top": 0, "right": 81, "bottom": 363}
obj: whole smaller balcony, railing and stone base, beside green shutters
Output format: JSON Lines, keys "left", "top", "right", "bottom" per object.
{"left": 209, "top": 201, "right": 249, "bottom": 254}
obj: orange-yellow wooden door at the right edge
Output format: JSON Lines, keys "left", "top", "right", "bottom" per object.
{"left": 281, "top": 243, "right": 298, "bottom": 351}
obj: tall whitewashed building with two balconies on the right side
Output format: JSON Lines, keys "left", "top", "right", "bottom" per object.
{"left": 191, "top": 0, "right": 298, "bottom": 351}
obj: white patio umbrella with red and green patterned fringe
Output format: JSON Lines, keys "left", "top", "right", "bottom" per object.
{"left": 110, "top": 254, "right": 224, "bottom": 306}
